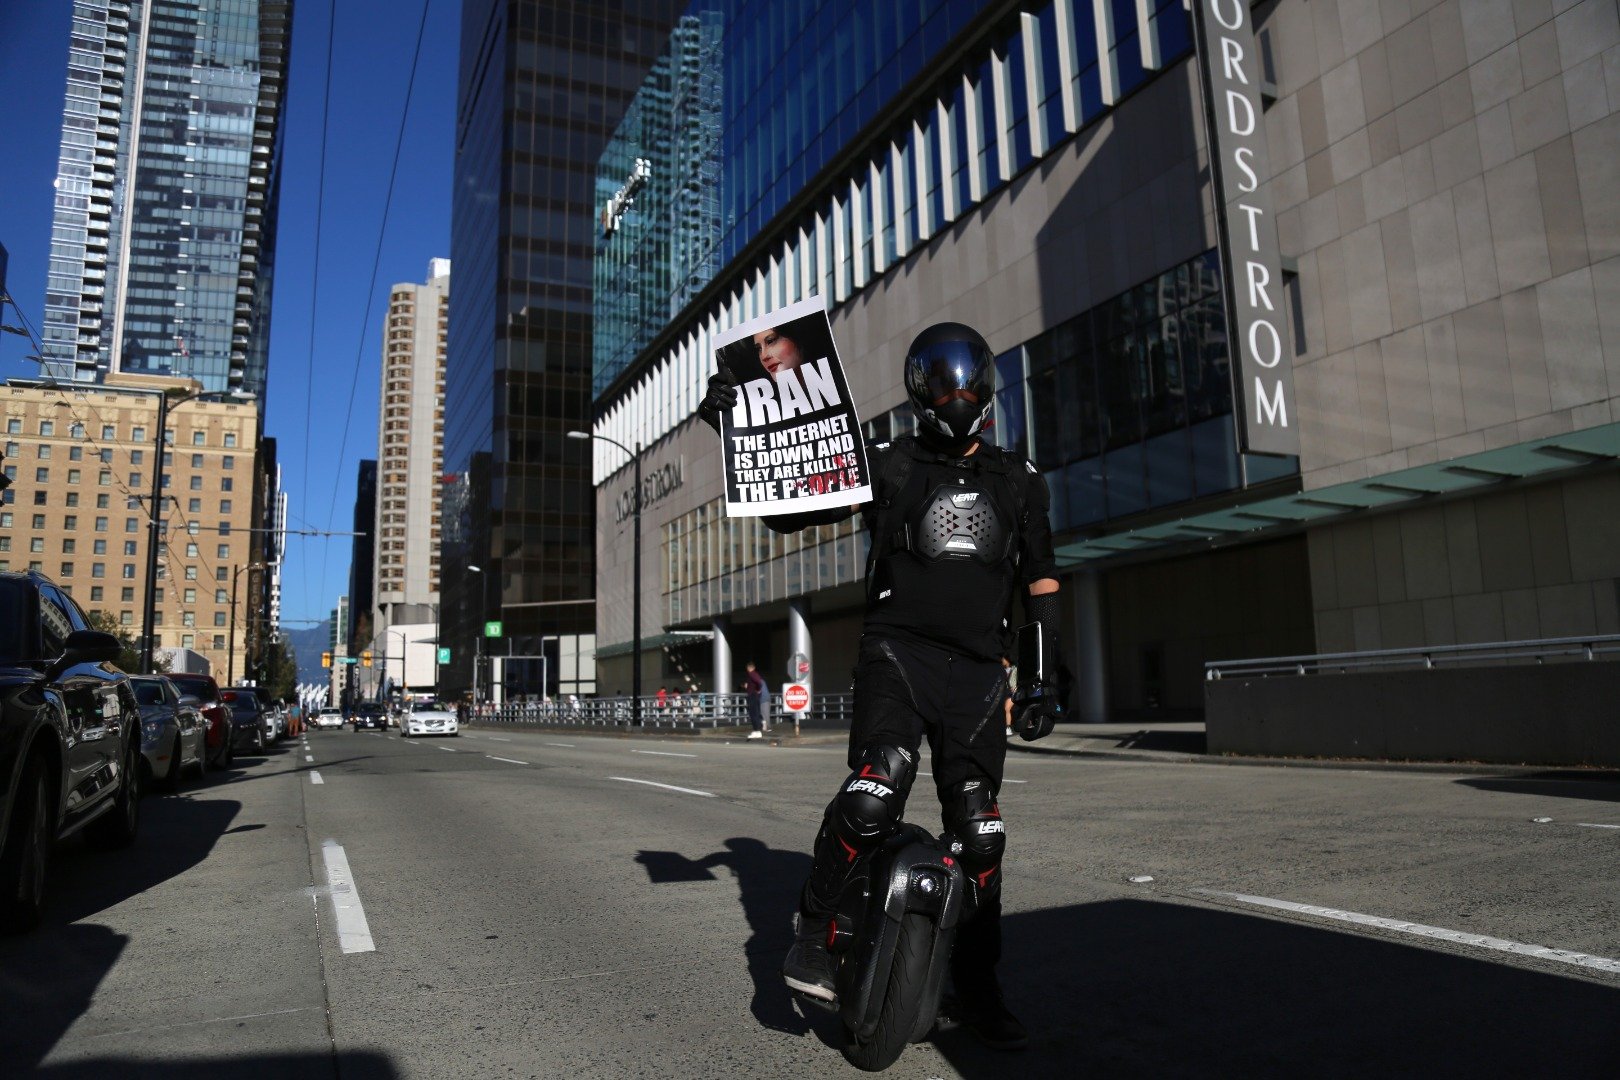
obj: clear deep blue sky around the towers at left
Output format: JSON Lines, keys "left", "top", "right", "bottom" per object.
{"left": 0, "top": 0, "right": 460, "bottom": 627}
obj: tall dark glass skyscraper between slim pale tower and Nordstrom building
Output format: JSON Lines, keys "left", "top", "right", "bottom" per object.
{"left": 441, "top": 0, "right": 679, "bottom": 690}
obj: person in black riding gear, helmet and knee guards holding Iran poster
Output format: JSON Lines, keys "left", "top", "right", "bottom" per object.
{"left": 698, "top": 322, "right": 1058, "bottom": 1049}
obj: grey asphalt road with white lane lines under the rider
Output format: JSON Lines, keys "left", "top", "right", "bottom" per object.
{"left": 0, "top": 730, "right": 1620, "bottom": 1080}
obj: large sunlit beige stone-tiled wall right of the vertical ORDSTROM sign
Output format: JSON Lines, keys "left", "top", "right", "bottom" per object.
{"left": 1257, "top": 0, "right": 1620, "bottom": 487}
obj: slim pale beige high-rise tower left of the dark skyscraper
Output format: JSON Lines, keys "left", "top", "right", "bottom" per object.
{"left": 371, "top": 259, "right": 450, "bottom": 682}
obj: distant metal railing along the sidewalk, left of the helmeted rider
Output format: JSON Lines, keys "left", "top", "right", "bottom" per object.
{"left": 468, "top": 693, "right": 854, "bottom": 730}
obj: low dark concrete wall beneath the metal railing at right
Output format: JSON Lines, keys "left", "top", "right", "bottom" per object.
{"left": 1205, "top": 662, "right": 1620, "bottom": 766}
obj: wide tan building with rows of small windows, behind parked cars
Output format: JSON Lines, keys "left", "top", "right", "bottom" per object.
{"left": 0, "top": 376, "right": 264, "bottom": 682}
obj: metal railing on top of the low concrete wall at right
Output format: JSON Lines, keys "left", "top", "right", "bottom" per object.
{"left": 1204, "top": 633, "right": 1620, "bottom": 682}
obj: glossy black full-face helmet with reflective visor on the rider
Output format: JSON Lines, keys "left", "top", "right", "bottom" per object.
{"left": 906, "top": 322, "right": 996, "bottom": 442}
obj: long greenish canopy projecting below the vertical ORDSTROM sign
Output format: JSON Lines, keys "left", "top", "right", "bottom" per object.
{"left": 1058, "top": 424, "right": 1620, "bottom": 570}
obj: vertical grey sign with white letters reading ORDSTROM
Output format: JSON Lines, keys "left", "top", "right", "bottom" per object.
{"left": 1192, "top": 0, "right": 1299, "bottom": 453}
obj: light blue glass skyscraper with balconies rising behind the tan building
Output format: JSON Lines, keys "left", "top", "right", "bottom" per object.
{"left": 42, "top": 0, "right": 292, "bottom": 397}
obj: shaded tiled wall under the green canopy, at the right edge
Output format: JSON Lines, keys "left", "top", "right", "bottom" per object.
{"left": 1309, "top": 471, "right": 1620, "bottom": 653}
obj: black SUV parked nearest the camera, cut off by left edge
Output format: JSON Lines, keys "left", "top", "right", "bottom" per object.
{"left": 0, "top": 572, "right": 141, "bottom": 933}
